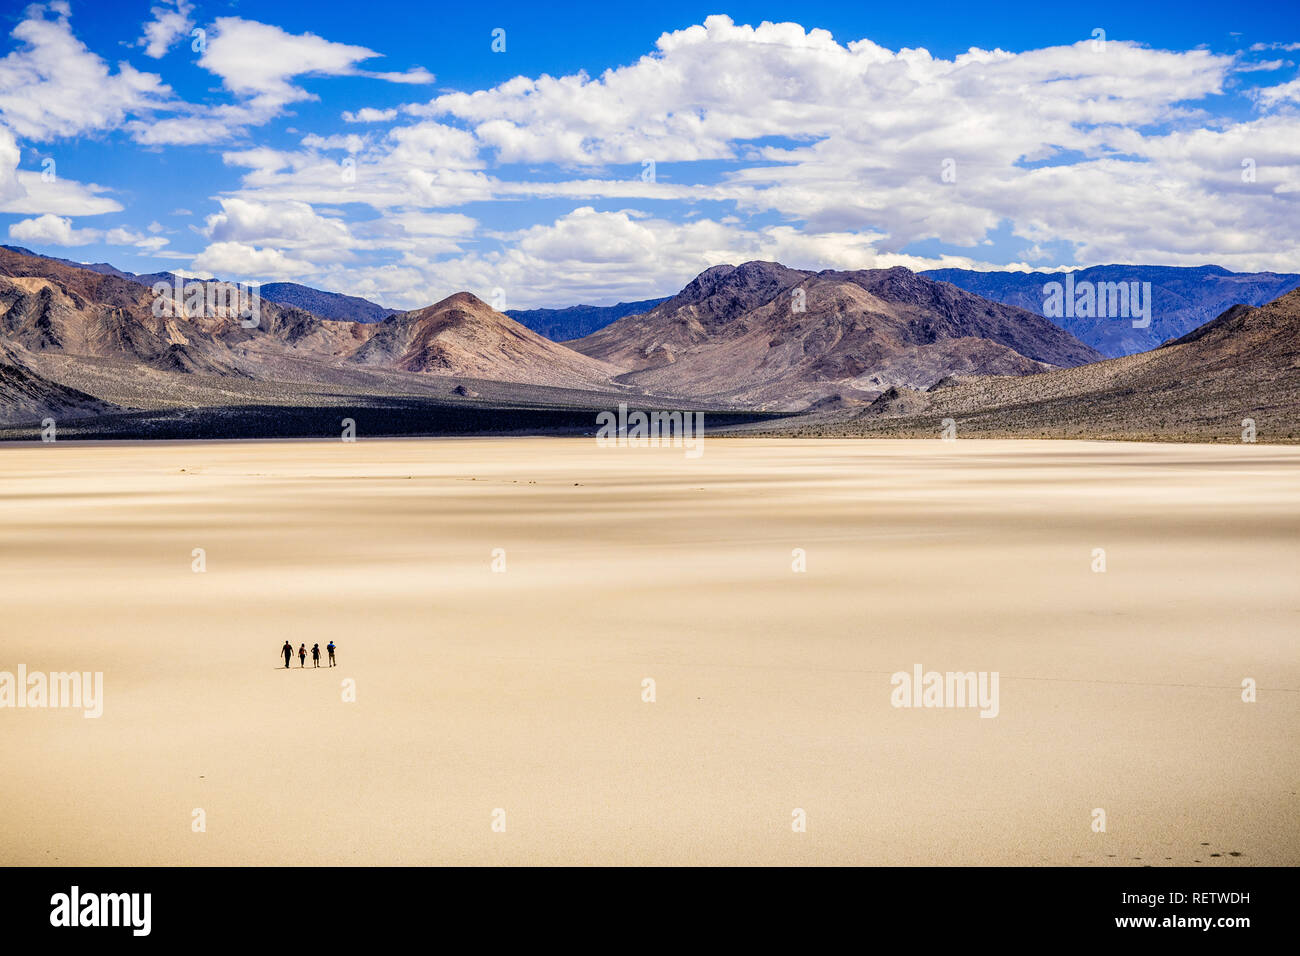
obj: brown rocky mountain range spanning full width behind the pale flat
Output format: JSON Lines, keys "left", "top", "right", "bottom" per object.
{"left": 0, "top": 247, "right": 1300, "bottom": 440}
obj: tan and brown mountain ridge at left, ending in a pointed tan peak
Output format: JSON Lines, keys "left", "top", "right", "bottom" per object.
{"left": 0, "top": 248, "right": 621, "bottom": 418}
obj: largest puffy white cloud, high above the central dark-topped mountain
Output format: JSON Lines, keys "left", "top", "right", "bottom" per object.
{"left": 408, "top": 16, "right": 1232, "bottom": 165}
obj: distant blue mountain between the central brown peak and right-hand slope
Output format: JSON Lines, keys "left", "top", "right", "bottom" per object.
{"left": 920, "top": 265, "right": 1300, "bottom": 358}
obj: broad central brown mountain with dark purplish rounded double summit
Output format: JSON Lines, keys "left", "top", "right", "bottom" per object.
{"left": 568, "top": 261, "right": 1101, "bottom": 408}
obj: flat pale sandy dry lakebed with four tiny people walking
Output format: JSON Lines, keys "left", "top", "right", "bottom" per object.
{"left": 0, "top": 438, "right": 1300, "bottom": 866}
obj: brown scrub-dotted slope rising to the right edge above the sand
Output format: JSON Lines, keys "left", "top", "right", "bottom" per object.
{"left": 788, "top": 289, "right": 1300, "bottom": 442}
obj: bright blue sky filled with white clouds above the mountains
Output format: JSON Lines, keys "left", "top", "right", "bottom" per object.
{"left": 0, "top": 0, "right": 1300, "bottom": 307}
